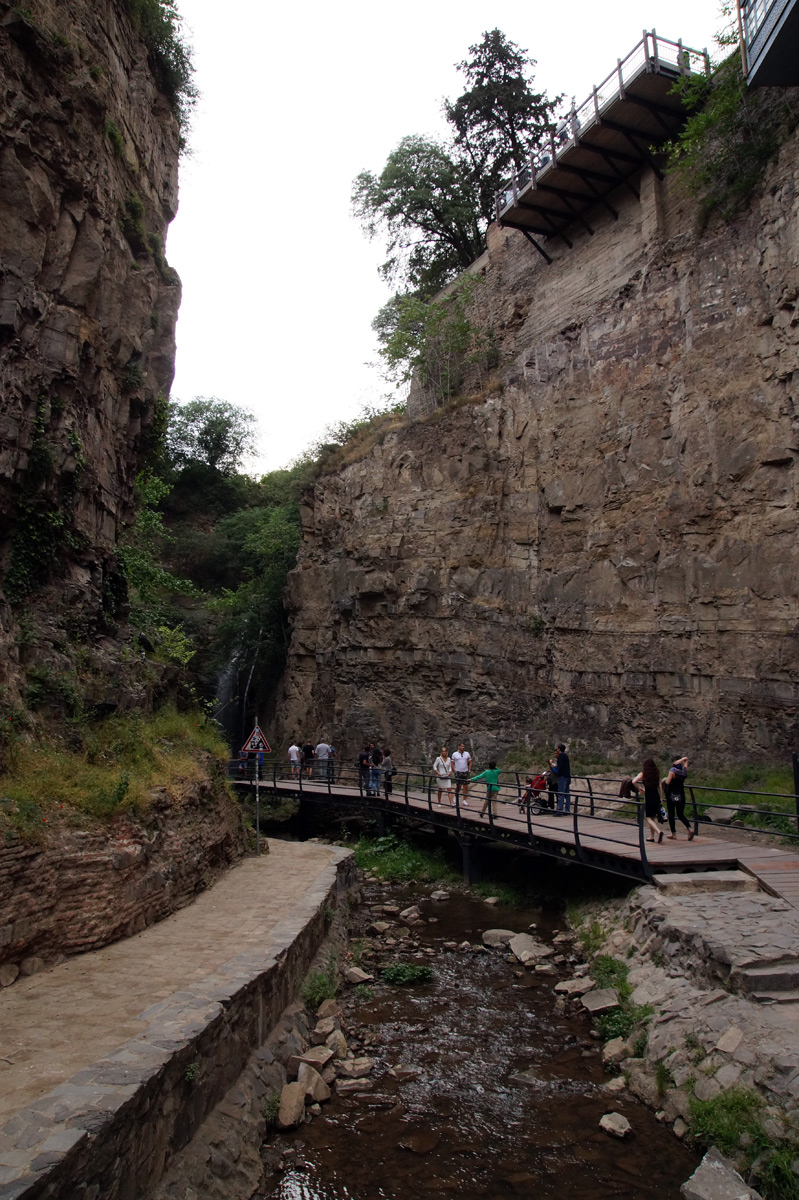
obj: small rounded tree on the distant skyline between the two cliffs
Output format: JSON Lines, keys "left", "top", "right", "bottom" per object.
{"left": 166, "top": 396, "right": 256, "bottom": 475}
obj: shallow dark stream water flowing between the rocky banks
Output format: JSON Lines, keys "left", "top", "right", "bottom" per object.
{"left": 266, "top": 886, "right": 698, "bottom": 1200}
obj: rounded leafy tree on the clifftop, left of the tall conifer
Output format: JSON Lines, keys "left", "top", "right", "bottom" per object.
{"left": 353, "top": 137, "right": 485, "bottom": 295}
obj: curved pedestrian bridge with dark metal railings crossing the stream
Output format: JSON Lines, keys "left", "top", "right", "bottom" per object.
{"left": 235, "top": 762, "right": 799, "bottom": 907}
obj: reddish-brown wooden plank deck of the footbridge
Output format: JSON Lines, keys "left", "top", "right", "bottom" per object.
{"left": 239, "top": 776, "right": 799, "bottom": 907}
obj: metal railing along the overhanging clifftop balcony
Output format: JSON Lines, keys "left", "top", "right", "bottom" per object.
{"left": 494, "top": 29, "right": 710, "bottom": 217}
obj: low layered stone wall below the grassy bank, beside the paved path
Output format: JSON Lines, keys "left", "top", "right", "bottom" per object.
{"left": 0, "top": 763, "right": 246, "bottom": 986}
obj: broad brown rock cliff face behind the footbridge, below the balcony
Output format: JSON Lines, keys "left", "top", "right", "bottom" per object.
{"left": 275, "top": 138, "right": 799, "bottom": 757}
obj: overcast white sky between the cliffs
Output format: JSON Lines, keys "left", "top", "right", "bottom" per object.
{"left": 167, "top": 0, "right": 721, "bottom": 470}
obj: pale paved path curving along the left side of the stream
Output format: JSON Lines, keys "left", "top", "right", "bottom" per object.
{"left": 0, "top": 839, "right": 336, "bottom": 1126}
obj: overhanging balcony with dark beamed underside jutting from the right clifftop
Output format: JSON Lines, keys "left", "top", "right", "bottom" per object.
{"left": 495, "top": 30, "right": 710, "bottom": 260}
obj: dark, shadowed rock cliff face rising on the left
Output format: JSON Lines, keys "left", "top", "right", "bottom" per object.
{"left": 0, "top": 0, "right": 180, "bottom": 692}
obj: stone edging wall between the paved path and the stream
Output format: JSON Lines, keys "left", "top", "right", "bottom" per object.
{"left": 0, "top": 847, "right": 355, "bottom": 1200}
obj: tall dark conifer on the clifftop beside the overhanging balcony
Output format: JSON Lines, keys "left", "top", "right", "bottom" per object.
{"left": 444, "top": 29, "right": 560, "bottom": 221}
